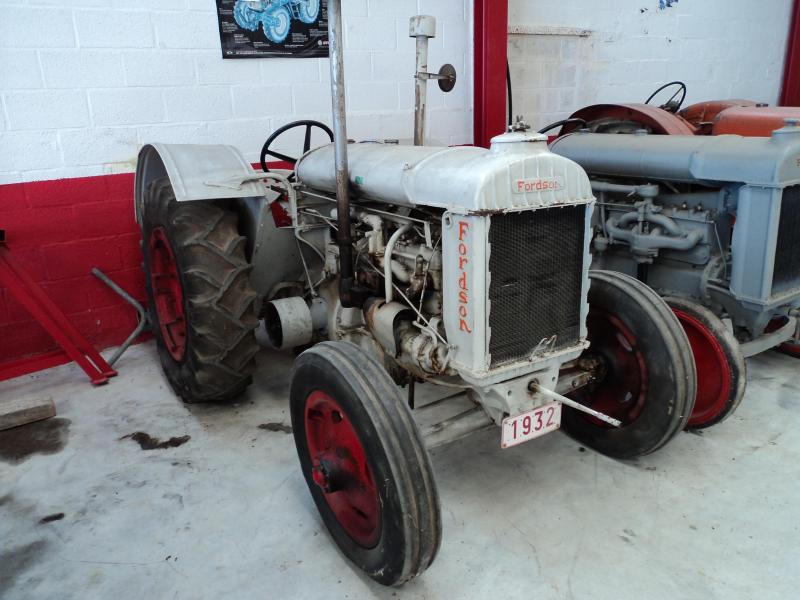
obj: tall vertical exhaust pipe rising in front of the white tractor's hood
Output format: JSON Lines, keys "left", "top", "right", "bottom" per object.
{"left": 328, "top": 0, "right": 353, "bottom": 307}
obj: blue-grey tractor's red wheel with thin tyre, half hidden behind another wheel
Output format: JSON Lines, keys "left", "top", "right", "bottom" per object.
{"left": 665, "top": 298, "right": 747, "bottom": 429}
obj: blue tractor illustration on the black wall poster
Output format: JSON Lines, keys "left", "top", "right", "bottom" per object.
{"left": 233, "top": 0, "right": 321, "bottom": 44}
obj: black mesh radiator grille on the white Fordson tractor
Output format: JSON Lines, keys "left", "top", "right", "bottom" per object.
{"left": 489, "top": 206, "right": 586, "bottom": 367}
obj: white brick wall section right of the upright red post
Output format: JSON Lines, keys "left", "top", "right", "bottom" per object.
{"left": 509, "top": 0, "right": 792, "bottom": 129}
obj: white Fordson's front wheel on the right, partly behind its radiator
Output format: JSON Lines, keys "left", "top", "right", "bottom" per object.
{"left": 562, "top": 271, "right": 696, "bottom": 458}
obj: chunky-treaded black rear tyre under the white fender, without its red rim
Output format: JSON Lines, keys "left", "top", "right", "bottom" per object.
{"left": 141, "top": 177, "right": 258, "bottom": 402}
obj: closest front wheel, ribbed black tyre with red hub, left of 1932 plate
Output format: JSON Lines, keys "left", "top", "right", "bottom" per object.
{"left": 290, "top": 342, "right": 442, "bottom": 585}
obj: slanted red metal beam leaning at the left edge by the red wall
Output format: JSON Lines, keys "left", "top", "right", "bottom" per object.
{"left": 0, "top": 229, "right": 117, "bottom": 385}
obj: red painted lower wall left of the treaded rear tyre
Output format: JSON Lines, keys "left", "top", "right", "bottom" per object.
{"left": 0, "top": 174, "right": 145, "bottom": 378}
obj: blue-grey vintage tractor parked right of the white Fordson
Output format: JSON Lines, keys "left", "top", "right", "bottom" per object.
{"left": 551, "top": 121, "right": 800, "bottom": 427}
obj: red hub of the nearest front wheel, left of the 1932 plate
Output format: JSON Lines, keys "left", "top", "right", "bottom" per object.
{"left": 305, "top": 391, "right": 381, "bottom": 548}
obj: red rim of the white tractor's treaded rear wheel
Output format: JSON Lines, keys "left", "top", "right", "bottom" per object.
{"left": 148, "top": 227, "right": 186, "bottom": 362}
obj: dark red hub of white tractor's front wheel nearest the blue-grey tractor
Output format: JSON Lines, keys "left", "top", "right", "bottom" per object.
{"left": 573, "top": 308, "right": 648, "bottom": 427}
